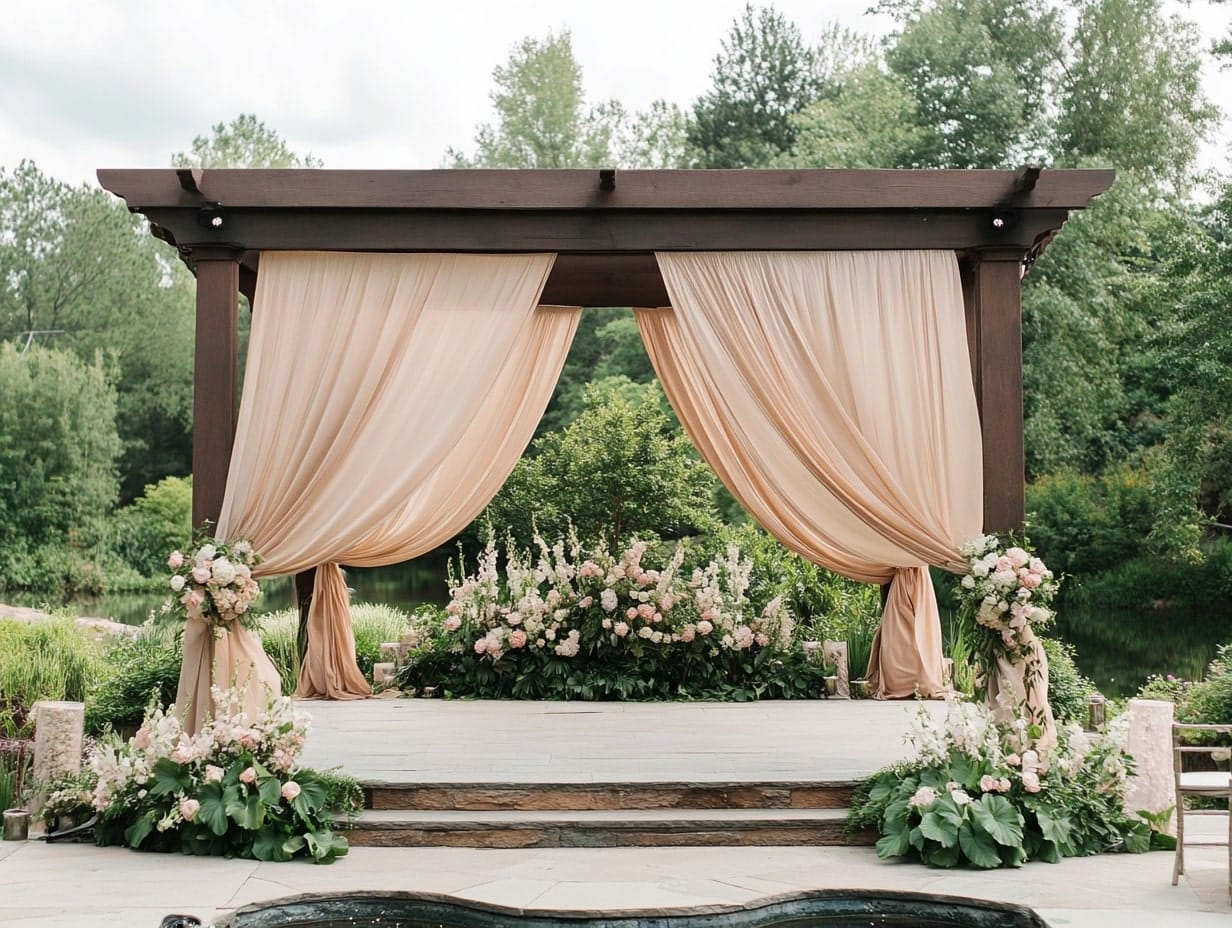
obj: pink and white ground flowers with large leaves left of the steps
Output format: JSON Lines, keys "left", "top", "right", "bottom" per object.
{"left": 91, "top": 688, "right": 347, "bottom": 863}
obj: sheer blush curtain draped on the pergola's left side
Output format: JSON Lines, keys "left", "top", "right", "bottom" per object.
{"left": 180, "top": 253, "right": 579, "bottom": 717}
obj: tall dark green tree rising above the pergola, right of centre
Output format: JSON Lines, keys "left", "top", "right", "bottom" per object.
{"left": 689, "top": 4, "right": 821, "bottom": 168}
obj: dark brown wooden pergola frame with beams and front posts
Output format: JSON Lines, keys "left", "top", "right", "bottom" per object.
{"left": 99, "top": 168, "right": 1114, "bottom": 531}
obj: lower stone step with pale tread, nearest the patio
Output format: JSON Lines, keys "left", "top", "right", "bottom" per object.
{"left": 345, "top": 808, "right": 877, "bottom": 848}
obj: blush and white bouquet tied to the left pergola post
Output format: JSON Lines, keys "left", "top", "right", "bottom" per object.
{"left": 163, "top": 537, "right": 261, "bottom": 637}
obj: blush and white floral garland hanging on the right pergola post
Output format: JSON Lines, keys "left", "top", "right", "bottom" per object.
{"left": 955, "top": 535, "right": 1061, "bottom": 719}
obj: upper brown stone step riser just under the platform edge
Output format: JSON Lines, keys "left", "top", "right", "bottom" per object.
{"left": 363, "top": 780, "right": 854, "bottom": 812}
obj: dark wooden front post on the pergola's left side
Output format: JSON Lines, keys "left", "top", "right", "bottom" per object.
{"left": 192, "top": 248, "right": 239, "bottom": 529}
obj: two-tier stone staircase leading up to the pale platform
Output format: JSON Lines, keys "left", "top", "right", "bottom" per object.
{"left": 346, "top": 781, "right": 876, "bottom": 848}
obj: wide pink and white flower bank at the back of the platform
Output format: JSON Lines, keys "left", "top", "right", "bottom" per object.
{"left": 403, "top": 536, "right": 822, "bottom": 699}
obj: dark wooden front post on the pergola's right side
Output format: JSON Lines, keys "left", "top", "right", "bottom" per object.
{"left": 962, "top": 248, "right": 1026, "bottom": 532}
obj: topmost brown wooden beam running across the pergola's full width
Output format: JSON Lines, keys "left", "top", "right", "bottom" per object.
{"left": 99, "top": 169, "right": 1114, "bottom": 212}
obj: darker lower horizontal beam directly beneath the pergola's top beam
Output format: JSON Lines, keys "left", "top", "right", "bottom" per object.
{"left": 139, "top": 207, "right": 1068, "bottom": 255}
